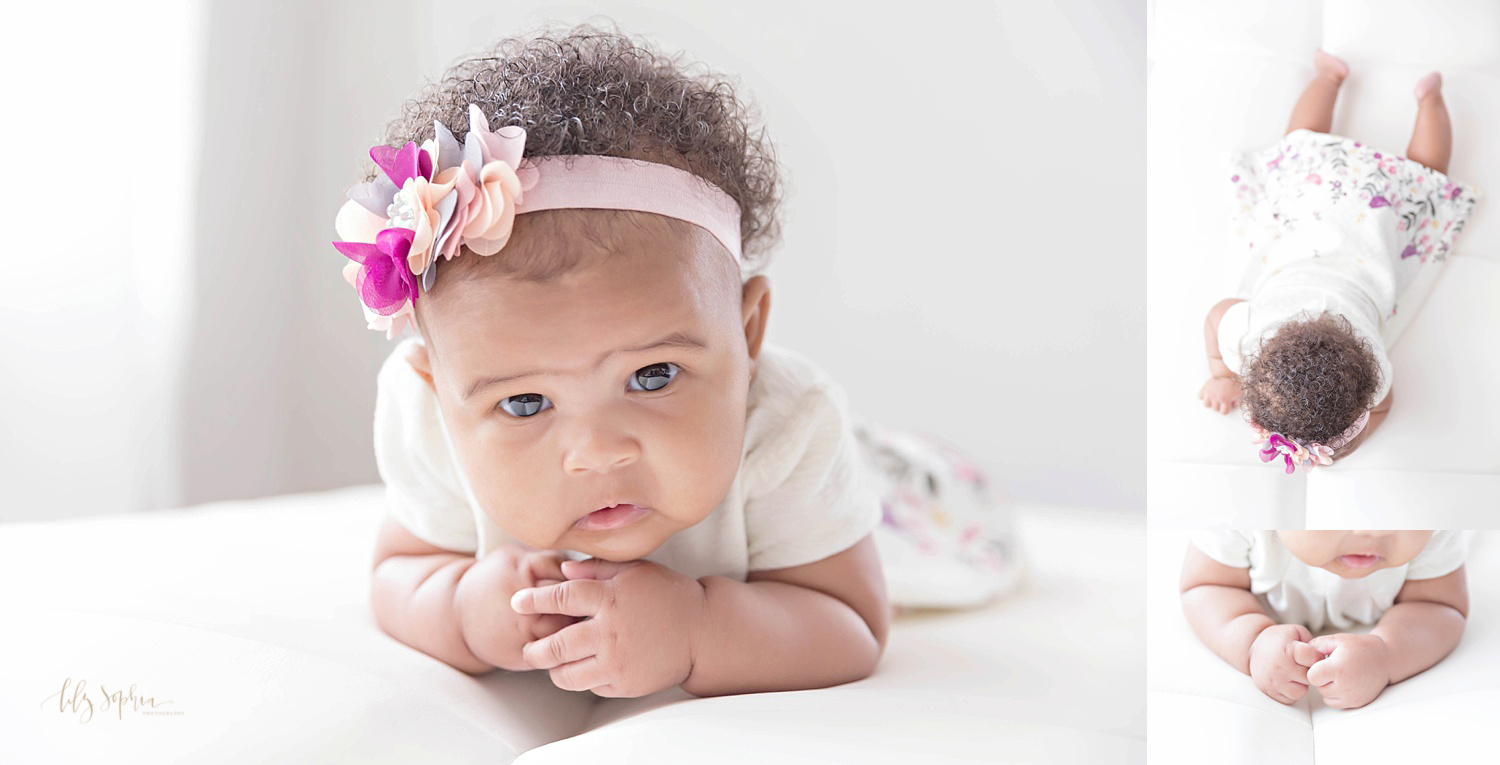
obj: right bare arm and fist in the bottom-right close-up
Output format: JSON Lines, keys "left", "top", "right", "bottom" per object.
{"left": 1308, "top": 567, "right": 1469, "bottom": 710}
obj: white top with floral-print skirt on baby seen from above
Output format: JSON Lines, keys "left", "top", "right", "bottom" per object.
{"left": 1218, "top": 131, "right": 1478, "bottom": 390}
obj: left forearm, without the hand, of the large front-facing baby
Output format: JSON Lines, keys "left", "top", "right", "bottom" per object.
{"left": 371, "top": 554, "right": 495, "bottom": 675}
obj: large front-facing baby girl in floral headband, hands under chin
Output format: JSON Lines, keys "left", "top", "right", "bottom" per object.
{"left": 343, "top": 27, "right": 1008, "bottom": 696}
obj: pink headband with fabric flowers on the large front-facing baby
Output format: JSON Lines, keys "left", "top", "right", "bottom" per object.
{"left": 333, "top": 104, "right": 741, "bottom": 339}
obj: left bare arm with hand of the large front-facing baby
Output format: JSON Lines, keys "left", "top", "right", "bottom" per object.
{"left": 371, "top": 518, "right": 573, "bottom": 675}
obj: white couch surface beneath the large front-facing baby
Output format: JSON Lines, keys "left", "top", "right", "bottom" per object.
{"left": 0, "top": 486, "right": 1145, "bottom": 765}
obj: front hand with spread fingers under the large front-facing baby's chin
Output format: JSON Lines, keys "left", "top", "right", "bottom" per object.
{"left": 512, "top": 558, "right": 705, "bottom": 698}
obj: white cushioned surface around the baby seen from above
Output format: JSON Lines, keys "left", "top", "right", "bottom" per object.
{"left": 1146, "top": 0, "right": 1500, "bottom": 528}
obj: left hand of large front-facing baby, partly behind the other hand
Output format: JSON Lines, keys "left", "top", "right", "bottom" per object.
{"left": 455, "top": 545, "right": 578, "bottom": 672}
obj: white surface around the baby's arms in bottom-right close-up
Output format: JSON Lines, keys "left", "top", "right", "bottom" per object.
{"left": 1146, "top": 530, "right": 1500, "bottom": 765}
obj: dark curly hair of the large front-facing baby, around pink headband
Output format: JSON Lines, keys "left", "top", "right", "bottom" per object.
{"left": 366, "top": 24, "right": 782, "bottom": 290}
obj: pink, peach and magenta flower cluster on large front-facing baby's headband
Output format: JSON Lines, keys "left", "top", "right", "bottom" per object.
{"left": 333, "top": 104, "right": 537, "bottom": 339}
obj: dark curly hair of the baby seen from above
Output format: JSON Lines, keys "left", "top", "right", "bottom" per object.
{"left": 1241, "top": 312, "right": 1382, "bottom": 443}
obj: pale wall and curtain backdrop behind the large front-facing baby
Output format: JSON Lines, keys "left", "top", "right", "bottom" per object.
{"left": 0, "top": 0, "right": 1145, "bottom": 519}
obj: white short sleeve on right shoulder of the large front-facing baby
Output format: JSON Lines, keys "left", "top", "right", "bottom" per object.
{"left": 743, "top": 347, "right": 881, "bottom": 572}
